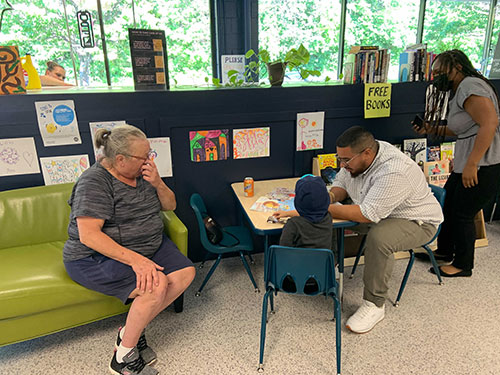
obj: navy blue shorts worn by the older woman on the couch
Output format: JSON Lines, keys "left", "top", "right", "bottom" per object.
{"left": 64, "top": 235, "right": 193, "bottom": 304}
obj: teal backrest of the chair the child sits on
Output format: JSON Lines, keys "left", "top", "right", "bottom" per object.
{"left": 264, "top": 245, "right": 337, "bottom": 294}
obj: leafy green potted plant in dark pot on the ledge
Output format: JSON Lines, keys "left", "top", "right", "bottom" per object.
{"left": 245, "top": 44, "right": 322, "bottom": 86}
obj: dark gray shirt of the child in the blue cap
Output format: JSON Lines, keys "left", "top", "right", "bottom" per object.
{"left": 280, "top": 213, "right": 335, "bottom": 250}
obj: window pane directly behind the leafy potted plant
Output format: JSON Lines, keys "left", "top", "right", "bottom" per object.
{"left": 259, "top": 0, "right": 340, "bottom": 81}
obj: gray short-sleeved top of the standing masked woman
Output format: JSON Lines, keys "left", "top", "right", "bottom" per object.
{"left": 448, "top": 77, "right": 500, "bottom": 173}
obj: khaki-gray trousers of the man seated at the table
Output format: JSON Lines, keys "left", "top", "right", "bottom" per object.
{"left": 352, "top": 219, "right": 437, "bottom": 307}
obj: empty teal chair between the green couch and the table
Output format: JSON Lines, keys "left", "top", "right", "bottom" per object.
{"left": 190, "top": 193, "right": 260, "bottom": 297}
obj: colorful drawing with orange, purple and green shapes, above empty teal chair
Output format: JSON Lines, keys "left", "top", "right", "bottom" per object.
{"left": 189, "top": 129, "right": 229, "bottom": 162}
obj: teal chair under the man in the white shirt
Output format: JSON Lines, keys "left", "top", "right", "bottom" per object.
{"left": 349, "top": 185, "right": 446, "bottom": 307}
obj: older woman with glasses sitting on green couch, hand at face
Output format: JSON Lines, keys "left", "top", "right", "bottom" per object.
{"left": 63, "top": 125, "right": 195, "bottom": 375}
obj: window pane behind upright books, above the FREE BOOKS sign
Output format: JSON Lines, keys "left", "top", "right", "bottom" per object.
{"left": 344, "top": 0, "right": 420, "bottom": 80}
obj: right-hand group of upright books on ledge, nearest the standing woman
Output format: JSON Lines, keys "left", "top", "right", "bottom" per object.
{"left": 399, "top": 43, "right": 436, "bottom": 82}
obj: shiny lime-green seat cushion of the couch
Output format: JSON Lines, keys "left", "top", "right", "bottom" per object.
{"left": 0, "top": 241, "right": 120, "bottom": 320}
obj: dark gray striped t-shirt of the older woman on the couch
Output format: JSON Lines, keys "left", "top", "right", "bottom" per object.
{"left": 63, "top": 162, "right": 163, "bottom": 261}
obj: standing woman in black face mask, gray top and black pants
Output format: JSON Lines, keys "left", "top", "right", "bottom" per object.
{"left": 414, "top": 49, "right": 500, "bottom": 277}
